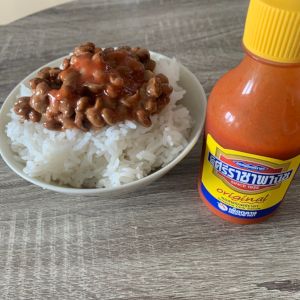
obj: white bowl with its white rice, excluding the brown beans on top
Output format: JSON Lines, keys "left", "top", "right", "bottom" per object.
{"left": 0, "top": 44, "right": 207, "bottom": 197}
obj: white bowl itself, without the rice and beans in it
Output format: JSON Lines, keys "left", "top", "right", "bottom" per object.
{"left": 0, "top": 52, "right": 207, "bottom": 197}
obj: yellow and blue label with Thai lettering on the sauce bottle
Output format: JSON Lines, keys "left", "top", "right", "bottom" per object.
{"left": 199, "top": 134, "right": 300, "bottom": 219}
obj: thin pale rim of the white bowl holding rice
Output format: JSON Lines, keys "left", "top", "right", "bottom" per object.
{"left": 0, "top": 51, "right": 207, "bottom": 195}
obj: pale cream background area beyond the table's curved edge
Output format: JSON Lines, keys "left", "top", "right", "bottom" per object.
{"left": 0, "top": 0, "right": 72, "bottom": 25}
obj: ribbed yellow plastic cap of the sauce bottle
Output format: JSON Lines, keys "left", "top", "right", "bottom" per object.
{"left": 243, "top": 0, "right": 300, "bottom": 63}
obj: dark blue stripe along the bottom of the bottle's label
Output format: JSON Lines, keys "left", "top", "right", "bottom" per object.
{"left": 200, "top": 183, "right": 281, "bottom": 219}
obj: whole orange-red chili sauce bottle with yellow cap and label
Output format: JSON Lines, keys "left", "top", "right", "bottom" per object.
{"left": 199, "top": 0, "right": 300, "bottom": 224}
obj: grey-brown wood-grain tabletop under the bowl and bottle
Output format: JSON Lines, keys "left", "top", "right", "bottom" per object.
{"left": 0, "top": 0, "right": 300, "bottom": 300}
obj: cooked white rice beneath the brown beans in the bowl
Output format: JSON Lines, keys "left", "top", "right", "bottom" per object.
{"left": 6, "top": 58, "right": 192, "bottom": 188}
